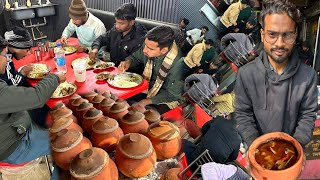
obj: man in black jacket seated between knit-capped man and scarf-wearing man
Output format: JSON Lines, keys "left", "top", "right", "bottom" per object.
{"left": 90, "top": 3, "right": 147, "bottom": 72}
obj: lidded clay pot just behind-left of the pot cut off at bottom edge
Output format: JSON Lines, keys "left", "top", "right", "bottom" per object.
{"left": 51, "top": 129, "right": 92, "bottom": 170}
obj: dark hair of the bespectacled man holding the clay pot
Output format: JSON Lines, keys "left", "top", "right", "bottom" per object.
{"left": 259, "top": 0, "right": 301, "bottom": 28}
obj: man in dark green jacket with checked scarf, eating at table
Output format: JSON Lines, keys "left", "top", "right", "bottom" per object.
{"left": 118, "top": 26, "right": 184, "bottom": 113}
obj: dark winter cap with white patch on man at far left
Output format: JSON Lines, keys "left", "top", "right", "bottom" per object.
{"left": 4, "top": 27, "right": 33, "bottom": 49}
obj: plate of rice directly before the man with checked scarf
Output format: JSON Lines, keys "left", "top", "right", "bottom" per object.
{"left": 107, "top": 72, "right": 143, "bottom": 89}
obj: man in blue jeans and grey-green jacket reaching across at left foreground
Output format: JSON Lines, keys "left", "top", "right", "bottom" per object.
{"left": 0, "top": 36, "right": 66, "bottom": 164}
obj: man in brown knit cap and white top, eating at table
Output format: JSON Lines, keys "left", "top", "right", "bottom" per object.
{"left": 61, "top": 0, "right": 106, "bottom": 52}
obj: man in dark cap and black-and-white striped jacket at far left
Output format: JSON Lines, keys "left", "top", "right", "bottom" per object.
{"left": 0, "top": 27, "right": 33, "bottom": 86}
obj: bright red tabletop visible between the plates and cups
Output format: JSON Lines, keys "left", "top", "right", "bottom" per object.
{"left": 13, "top": 38, "right": 148, "bottom": 108}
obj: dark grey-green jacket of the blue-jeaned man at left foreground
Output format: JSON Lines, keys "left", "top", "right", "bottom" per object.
{"left": 0, "top": 74, "right": 59, "bottom": 160}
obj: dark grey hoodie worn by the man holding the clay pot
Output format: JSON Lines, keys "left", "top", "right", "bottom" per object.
{"left": 235, "top": 50, "right": 317, "bottom": 146}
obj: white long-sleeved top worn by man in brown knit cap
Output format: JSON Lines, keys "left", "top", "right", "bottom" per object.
{"left": 62, "top": 12, "right": 106, "bottom": 47}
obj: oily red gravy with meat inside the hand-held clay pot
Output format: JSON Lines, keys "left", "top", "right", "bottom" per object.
{"left": 255, "top": 139, "right": 298, "bottom": 170}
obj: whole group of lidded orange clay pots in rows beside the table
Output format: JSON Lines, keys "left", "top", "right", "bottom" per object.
{"left": 50, "top": 91, "right": 181, "bottom": 180}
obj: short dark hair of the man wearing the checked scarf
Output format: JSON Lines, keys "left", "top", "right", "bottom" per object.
{"left": 146, "top": 26, "right": 174, "bottom": 49}
